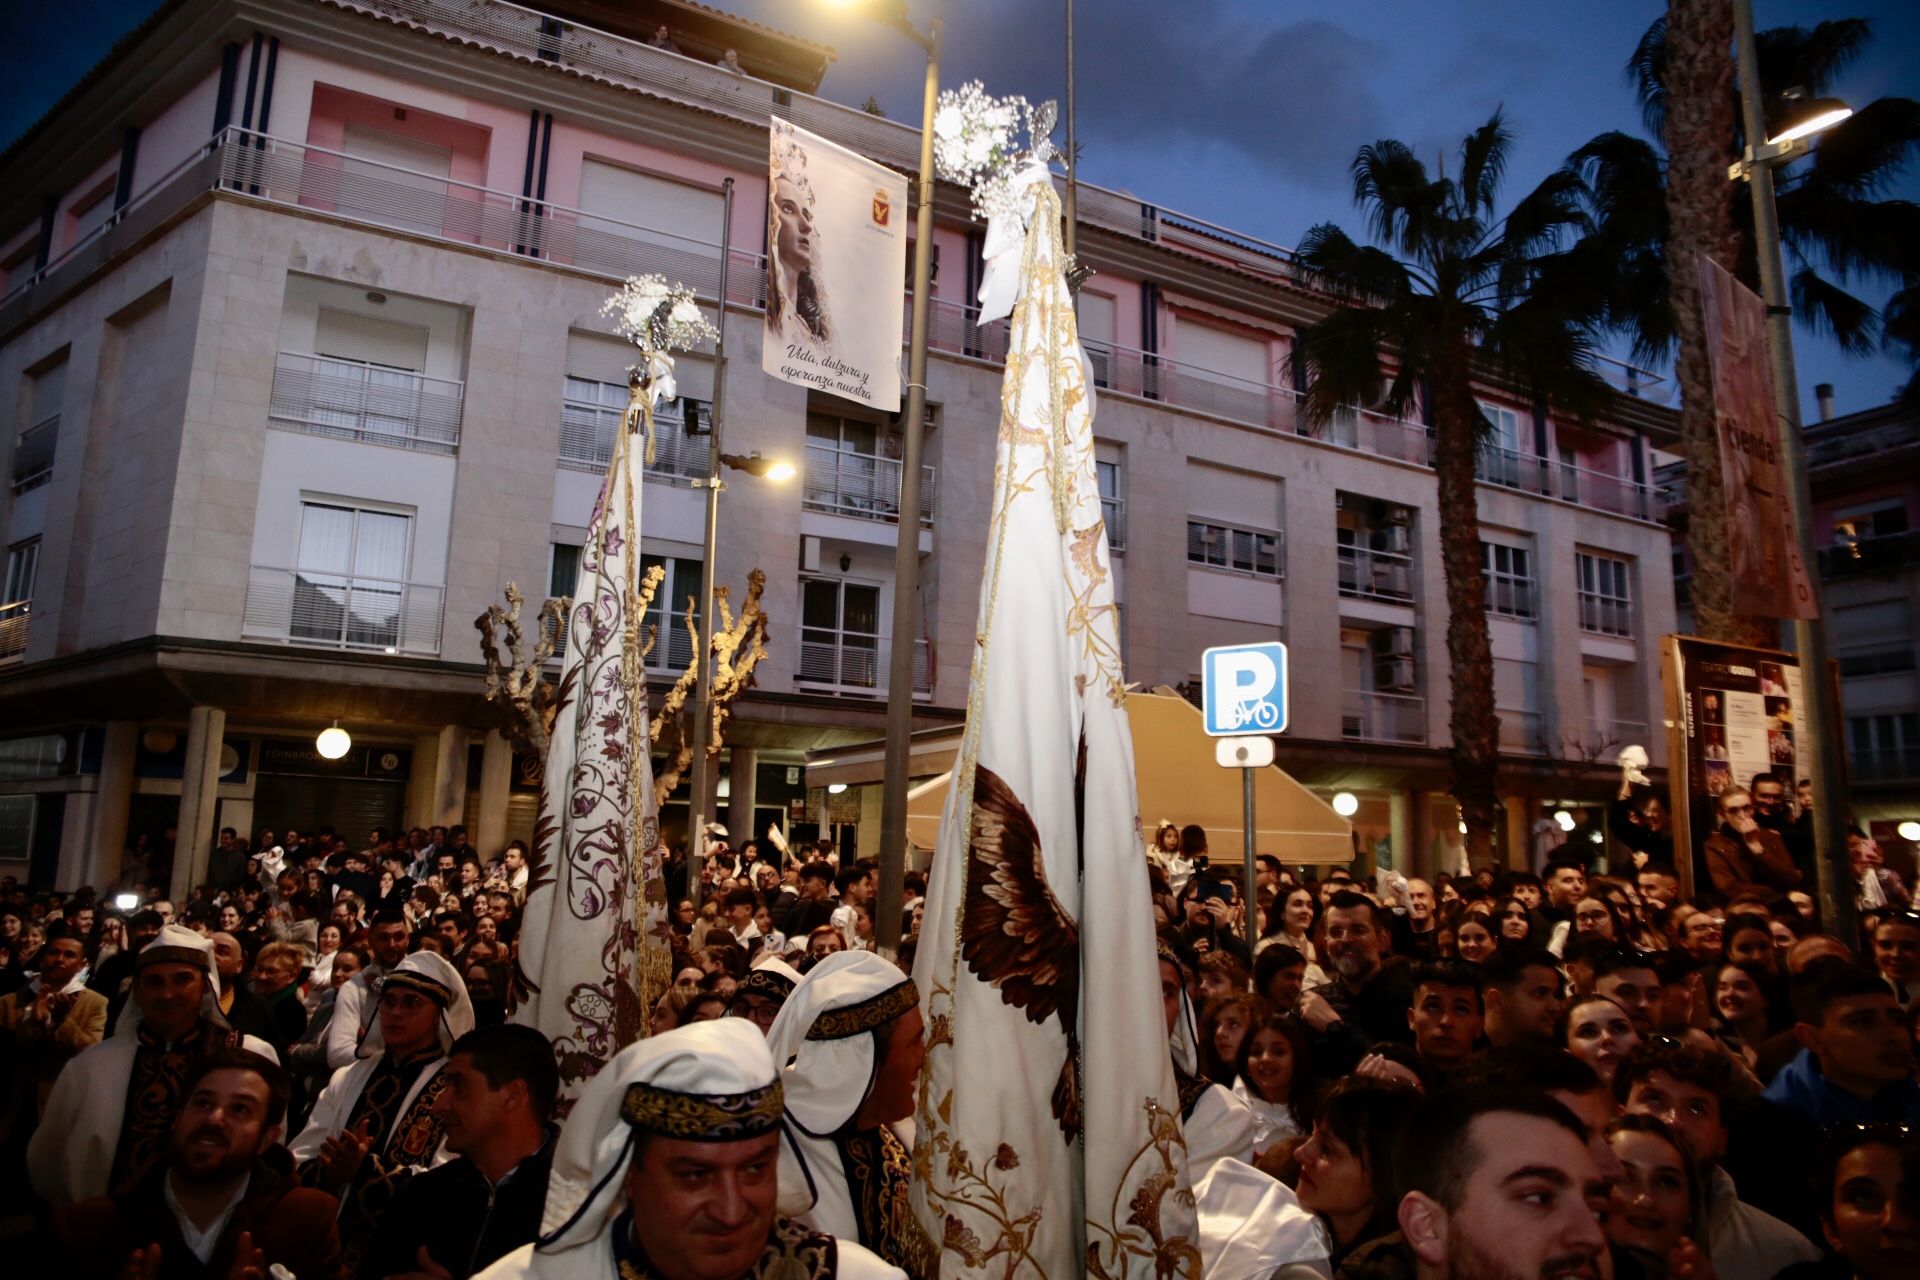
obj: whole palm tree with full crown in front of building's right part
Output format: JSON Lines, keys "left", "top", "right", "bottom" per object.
{"left": 1292, "top": 111, "right": 1609, "bottom": 865}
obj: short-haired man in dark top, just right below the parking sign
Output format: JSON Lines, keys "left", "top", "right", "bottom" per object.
{"left": 1300, "top": 890, "right": 1413, "bottom": 1080}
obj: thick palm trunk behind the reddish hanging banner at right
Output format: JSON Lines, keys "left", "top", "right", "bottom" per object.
{"left": 1665, "top": 0, "right": 1780, "bottom": 649}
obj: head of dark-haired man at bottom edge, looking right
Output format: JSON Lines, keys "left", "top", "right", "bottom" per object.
{"left": 1398, "top": 1088, "right": 1611, "bottom": 1280}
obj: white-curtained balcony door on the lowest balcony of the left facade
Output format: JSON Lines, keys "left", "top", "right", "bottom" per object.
{"left": 288, "top": 503, "right": 413, "bottom": 651}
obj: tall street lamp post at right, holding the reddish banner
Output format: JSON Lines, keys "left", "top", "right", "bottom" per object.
{"left": 1730, "top": 0, "right": 1855, "bottom": 938}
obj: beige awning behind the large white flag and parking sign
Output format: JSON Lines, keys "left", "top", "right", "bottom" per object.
{"left": 906, "top": 693, "right": 1354, "bottom": 865}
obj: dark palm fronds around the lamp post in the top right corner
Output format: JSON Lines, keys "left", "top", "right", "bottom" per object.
{"left": 1569, "top": 14, "right": 1920, "bottom": 395}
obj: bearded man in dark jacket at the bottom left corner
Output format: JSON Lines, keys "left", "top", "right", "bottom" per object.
{"left": 54, "top": 1050, "right": 344, "bottom": 1280}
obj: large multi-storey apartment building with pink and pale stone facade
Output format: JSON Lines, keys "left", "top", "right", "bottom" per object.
{"left": 0, "top": 0, "right": 1674, "bottom": 885}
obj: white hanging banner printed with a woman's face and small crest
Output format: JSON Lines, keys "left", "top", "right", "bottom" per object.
{"left": 760, "top": 119, "right": 906, "bottom": 413}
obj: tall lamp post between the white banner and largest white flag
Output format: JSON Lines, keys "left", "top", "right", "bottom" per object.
{"left": 828, "top": 0, "right": 941, "bottom": 954}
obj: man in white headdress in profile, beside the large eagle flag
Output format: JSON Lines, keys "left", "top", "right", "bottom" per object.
{"left": 766, "top": 952, "right": 933, "bottom": 1276}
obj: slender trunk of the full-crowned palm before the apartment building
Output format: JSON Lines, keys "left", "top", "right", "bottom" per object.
{"left": 1432, "top": 328, "right": 1500, "bottom": 869}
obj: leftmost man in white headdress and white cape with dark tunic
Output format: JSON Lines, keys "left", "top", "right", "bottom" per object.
{"left": 27, "top": 925, "right": 238, "bottom": 1209}
